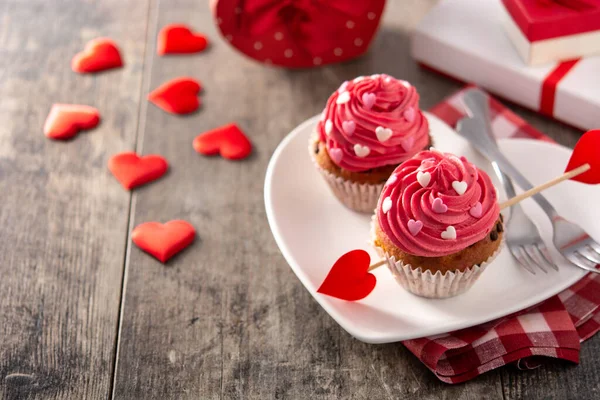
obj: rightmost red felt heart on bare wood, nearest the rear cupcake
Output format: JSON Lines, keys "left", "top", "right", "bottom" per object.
{"left": 194, "top": 123, "right": 252, "bottom": 160}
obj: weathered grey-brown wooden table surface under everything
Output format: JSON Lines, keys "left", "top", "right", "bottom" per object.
{"left": 0, "top": 0, "right": 600, "bottom": 400}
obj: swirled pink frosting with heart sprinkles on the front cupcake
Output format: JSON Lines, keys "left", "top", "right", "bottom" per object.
{"left": 376, "top": 150, "right": 500, "bottom": 257}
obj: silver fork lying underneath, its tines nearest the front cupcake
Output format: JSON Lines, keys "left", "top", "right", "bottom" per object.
{"left": 457, "top": 98, "right": 558, "bottom": 275}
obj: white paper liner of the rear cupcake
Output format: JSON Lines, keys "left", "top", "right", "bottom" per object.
{"left": 309, "top": 137, "right": 385, "bottom": 214}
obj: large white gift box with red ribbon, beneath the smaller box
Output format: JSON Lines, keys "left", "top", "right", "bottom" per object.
{"left": 412, "top": 0, "right": 600, "bottom": 130}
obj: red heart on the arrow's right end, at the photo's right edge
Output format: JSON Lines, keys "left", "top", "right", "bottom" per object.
{"left": 565, "top": 129, "right": 600, "bottom": 184}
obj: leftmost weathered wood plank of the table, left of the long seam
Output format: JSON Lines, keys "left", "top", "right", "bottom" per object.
{"left": 0, "top": 0, "right": 148, "bottom": 399}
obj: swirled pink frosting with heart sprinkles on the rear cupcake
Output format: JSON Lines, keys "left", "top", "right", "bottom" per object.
{"left": 317, "top": 74, "right": 429, "bottom": 172}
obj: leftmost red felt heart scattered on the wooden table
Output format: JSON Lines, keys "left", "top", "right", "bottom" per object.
{"left": 44, "top": 104, "right": 100, "bottom": 140}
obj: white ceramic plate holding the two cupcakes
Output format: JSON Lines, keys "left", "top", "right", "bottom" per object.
{"left": 265, "top": 114, "right": 600, "bottom": 343}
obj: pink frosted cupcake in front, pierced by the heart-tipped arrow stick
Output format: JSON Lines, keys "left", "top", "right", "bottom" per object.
{"left": 373, "top": 150, "right": 504, "bottom": 297}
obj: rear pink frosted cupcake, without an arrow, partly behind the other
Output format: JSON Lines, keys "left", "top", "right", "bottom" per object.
{"left": 309, "top": 75, "right": 431, "bottom": 213}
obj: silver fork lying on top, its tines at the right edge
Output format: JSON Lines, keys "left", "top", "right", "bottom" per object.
{"left": 461, "top": 89, "right": 600, "bottom": 273}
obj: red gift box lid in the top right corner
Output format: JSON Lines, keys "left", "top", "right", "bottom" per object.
{"left": 502, "top": 0, "right": 600, "bottom": 42}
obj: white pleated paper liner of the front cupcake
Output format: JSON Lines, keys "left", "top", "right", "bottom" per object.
{"left": 371, "top": 217, "right": 504, "bottom": 299}
